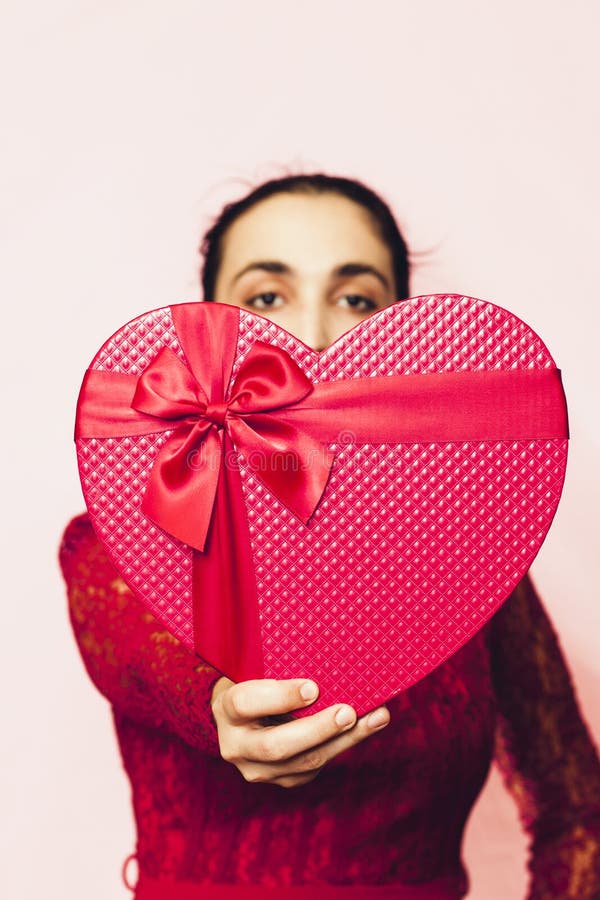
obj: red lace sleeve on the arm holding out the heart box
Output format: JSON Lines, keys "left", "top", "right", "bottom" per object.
{"left": 59, "top": 515, "right": 220, "bottom": 755}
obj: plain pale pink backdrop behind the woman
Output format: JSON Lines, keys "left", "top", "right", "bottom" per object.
{"left": 0, "top": 0, "right": 600, "bottom": 900}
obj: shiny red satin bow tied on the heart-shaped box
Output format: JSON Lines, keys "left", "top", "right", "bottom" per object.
{"left": 131, "top": 341, "right": 333, "bottom": 551}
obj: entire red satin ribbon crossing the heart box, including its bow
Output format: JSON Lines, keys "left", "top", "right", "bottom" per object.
{"left": 75, "top": 303, "right": 568, "bottom": 681}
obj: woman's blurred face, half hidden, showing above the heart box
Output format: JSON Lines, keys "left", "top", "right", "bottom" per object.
{"left": 213, "top": 193, "right": 396, "bottom": 351}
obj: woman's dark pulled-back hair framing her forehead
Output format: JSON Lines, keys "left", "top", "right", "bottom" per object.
{"left": 200, "top": 172, "right": 409, "bottom": 300}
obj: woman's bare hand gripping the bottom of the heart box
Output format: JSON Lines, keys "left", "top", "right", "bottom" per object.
{"left": 211, "top": 677, "right": 390, "bottom": 787}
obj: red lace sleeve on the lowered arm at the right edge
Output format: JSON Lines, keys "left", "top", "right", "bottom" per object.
{"left": 488, "top": 577, "right": 600, "bottom": 900}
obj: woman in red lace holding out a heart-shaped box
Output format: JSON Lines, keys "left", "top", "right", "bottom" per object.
{"left": 61, "top": 175, "right": 600, "bottom": 900}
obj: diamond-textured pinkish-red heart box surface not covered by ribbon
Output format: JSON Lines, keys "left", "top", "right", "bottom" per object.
{"left": 77, "top": 295, "right": 567, "bottom": 712}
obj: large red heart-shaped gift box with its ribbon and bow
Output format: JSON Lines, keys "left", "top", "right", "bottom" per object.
{"left": 76, "top": 294, "right": 568, "bottom": 714}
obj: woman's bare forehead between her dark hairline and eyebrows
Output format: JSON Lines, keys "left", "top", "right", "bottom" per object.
{"left": 221, "top": 193, "right": 391, "bottom": 276}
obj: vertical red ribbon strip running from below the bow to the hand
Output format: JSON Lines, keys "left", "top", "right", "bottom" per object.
{"left": 192, "top": 434, "right": 264, "bottom": 681}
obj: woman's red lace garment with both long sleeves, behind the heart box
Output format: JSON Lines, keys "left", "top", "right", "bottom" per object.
{"left": 60, "top": 516, "right": 600, "bottom": 900}
